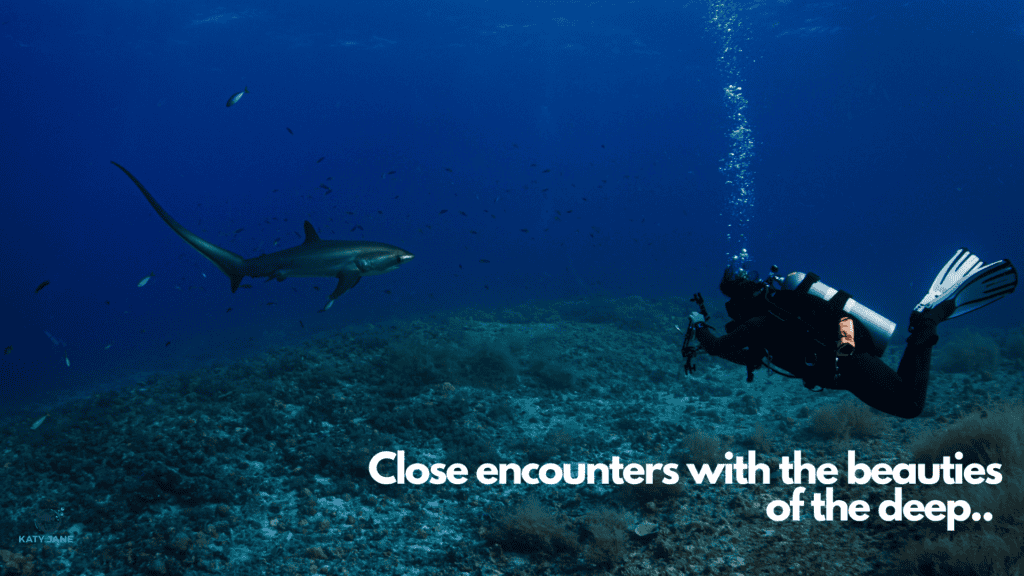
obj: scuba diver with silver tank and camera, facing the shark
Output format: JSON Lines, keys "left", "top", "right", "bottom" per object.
{"left": 677, "top": 248, "right": 1017, "bottom": 418}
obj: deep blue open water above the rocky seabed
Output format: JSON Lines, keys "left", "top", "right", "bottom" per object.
{"left": 0, "top": 0, "right": 1024, "bottom": 406}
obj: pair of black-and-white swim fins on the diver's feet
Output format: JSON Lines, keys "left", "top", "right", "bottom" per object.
{"left": 913, "top": 248, "right": 1017, "bottom": 321}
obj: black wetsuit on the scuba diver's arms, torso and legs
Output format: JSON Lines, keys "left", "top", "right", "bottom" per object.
{"left": 694, "top": 292, "right": 938, "bottom": 418}
